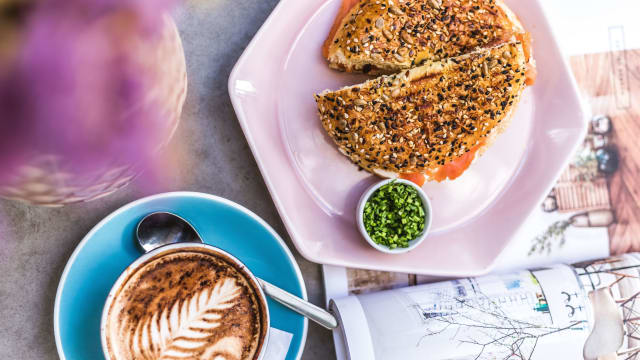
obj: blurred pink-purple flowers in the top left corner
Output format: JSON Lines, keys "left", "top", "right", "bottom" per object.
{"left": 0, "top": 0, "right": 178, "bottom": 182}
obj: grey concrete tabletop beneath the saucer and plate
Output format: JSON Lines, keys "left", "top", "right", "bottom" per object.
{"left": 0, "top": 0, "right": 335, "bottom": 360}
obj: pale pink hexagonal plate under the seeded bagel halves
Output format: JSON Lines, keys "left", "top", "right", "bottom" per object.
{"left": 229, "top": 0, "right": 586, "bottom": 276}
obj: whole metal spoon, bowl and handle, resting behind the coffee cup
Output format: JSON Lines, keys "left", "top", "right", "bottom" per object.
{"left": 136, "top": 212, "right": 338, "bottom": 330}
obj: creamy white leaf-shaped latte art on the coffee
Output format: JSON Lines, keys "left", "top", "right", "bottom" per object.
{"left": 128, "top": 279, "right": 241, "bottom": 359}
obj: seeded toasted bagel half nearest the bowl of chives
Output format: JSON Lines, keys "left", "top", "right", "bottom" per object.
{"left": 315, "top": 41, "right": 527, "bottom": 181}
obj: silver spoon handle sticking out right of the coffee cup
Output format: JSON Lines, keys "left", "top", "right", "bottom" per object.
{"left": 258, "top": 279, "right": 338, "bottom": 330}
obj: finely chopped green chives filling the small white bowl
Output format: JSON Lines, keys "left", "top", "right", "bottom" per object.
{"left": 363, "top": 181, "right": 426, "bottom": 249}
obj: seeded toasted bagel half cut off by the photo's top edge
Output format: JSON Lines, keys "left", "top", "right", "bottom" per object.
{"left": 323, "top": 0, "right": 531, "bottom": 81}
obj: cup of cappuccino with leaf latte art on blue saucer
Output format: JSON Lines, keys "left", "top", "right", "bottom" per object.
{"left": 103, "top": 245, "right": 268, "bottom": 360}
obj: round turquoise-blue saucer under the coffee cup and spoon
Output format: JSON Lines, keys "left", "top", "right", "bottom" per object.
{"left": 53, "top": 192, "right": 307, "bottom": 360}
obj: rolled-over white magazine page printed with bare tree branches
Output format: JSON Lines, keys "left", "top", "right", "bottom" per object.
{"left": 329, "top": 253, "right": 640, "bottom": 360}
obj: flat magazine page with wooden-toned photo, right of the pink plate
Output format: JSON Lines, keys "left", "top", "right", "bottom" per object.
{"left": 496, "top": 0, "right": 640, "bottom": 271}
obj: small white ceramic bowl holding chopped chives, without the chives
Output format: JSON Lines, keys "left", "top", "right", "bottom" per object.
{"left": 356, "top": 179, "right": 432, "bottom": 254}
